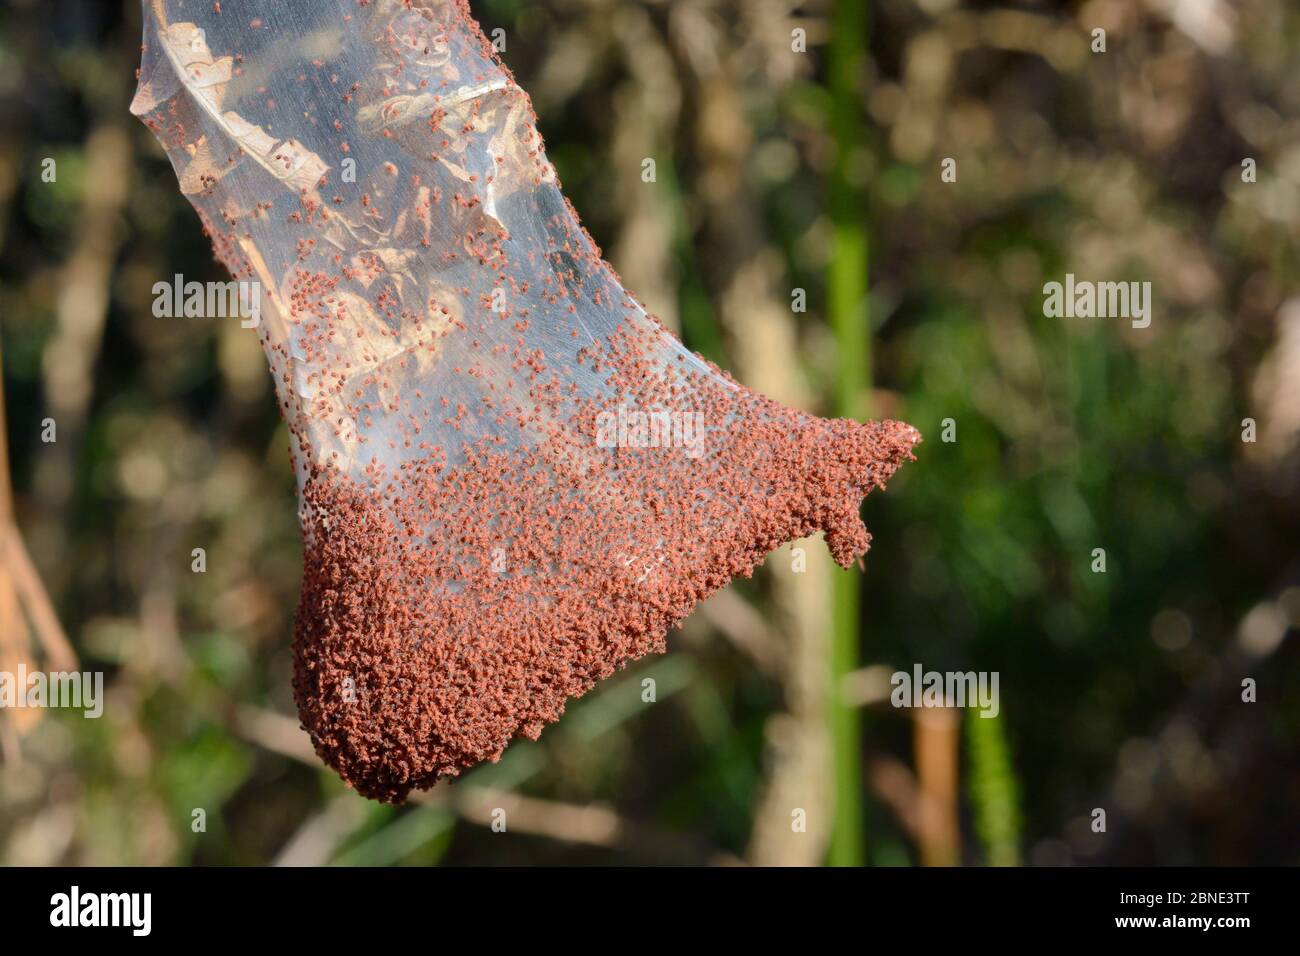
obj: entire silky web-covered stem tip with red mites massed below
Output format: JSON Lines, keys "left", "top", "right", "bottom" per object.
{"left": 133, "top": 0, "right": 919, "bottom": 801}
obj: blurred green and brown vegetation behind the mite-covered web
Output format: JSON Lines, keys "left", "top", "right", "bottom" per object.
{"left": 0, "top": 0, "right": 1300, "bottom": 865}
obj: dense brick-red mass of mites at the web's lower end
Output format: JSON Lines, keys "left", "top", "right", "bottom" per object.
{"left": 294, "top": 332, "right": 918, "bottom": 801}
